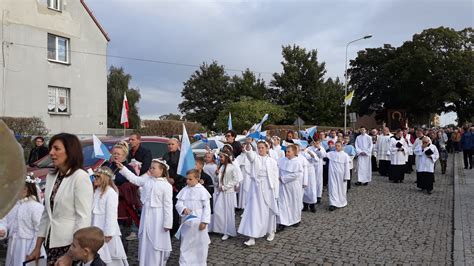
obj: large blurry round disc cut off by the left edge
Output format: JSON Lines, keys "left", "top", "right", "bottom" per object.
{"left": 0, "top": 120, "right": 26, "bottom": 218}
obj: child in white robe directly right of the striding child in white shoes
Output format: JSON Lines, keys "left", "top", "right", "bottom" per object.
{"left": 277, "top": 145, "right": 303, "bottom": 231}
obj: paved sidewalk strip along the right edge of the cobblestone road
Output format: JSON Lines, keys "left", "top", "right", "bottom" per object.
{"left": 453, "top": 153, "right": 474, "bottom": 265}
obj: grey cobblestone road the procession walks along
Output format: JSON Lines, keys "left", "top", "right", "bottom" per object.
{"left": 0, "top": 156, "right": 458, "bottom": 265}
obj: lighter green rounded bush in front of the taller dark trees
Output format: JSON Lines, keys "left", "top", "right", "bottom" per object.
{"left": 217, "top": 98, "right": 286, "bottom": 133}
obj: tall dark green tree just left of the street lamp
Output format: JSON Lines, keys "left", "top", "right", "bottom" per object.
{"left": 267, "top": 45, "right": 344, "bottom": 125}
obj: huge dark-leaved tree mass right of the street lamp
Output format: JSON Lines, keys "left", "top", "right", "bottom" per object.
{"left": 349, "top": 27, "right": 474, "bottom": 123}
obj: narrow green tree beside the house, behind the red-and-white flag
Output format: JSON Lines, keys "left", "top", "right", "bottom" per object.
{"left": 107, "top": 66, "right": 141, "bottom": 128}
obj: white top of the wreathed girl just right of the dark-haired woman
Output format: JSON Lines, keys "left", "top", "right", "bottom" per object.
{"left": 92, "top": 187, "right": 122, "bottom": 236}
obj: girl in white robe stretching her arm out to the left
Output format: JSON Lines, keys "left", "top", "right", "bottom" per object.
{"left": 117, "top": 159, "right": 173, "bottom": 266}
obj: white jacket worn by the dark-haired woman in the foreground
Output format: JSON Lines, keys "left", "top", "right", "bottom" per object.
{"left": 38, "top": 169, "right": 93, "bottom": 248}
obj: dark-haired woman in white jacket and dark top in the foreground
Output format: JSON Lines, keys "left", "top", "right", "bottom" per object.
{"left": 27, "top": 133, "right": 93, "bottom": 265}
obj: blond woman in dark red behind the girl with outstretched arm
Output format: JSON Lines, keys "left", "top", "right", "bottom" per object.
{"left": 104, "top": 141, "right": 141, "bottom": 240}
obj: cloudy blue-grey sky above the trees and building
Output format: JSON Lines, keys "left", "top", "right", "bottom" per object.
{"left": 86, "top": 0, "right": 474, "bottom": 123}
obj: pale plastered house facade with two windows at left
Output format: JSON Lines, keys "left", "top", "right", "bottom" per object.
{"left": 0, "top": 0, "right": 109, "bottom": 136}
